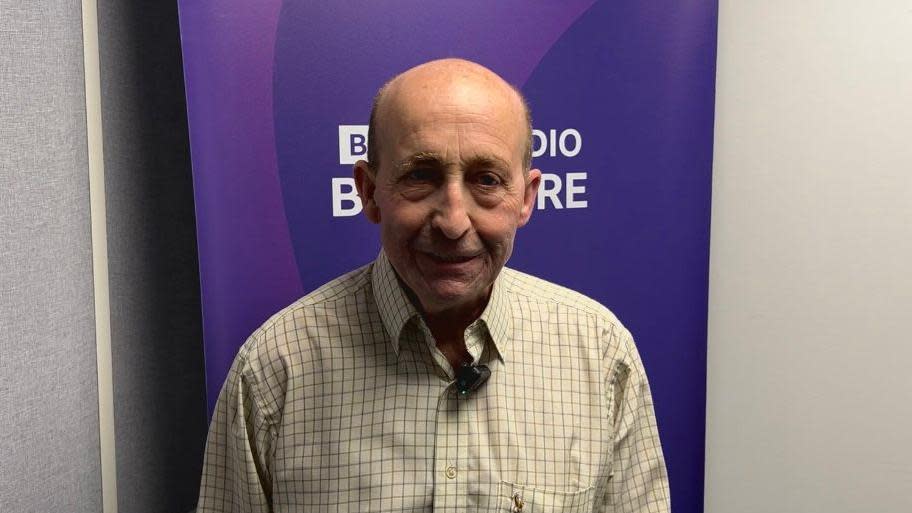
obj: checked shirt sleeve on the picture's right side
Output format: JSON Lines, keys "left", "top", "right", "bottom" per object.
{"left": 602, "top": 330, "right": 671, "bottom": 513}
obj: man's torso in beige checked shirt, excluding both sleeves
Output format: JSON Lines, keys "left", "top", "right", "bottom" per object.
{"left": 232, "top": 254, "right": 638, "bottom": 512}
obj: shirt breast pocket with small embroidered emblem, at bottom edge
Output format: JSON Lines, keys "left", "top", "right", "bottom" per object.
{"left": 497, "top": 481, "right": 595, "bottom": 513}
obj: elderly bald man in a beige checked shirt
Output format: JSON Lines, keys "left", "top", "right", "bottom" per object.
{"left": 197, "top": 59, "right": 669, "bottom": 513}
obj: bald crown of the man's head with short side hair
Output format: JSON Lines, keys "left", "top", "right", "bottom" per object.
{"left": 367, "top": 59, "right": 532, "bottom": 172}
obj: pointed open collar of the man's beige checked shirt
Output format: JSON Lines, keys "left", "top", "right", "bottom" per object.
{"left": 371, "top": 250, "right": 512, "bottom": 358}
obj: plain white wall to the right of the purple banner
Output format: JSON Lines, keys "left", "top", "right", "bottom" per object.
{"left": 706, "top": 0, "right": 912, "bottom": 513}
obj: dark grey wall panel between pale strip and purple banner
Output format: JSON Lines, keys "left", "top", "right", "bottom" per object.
{"left": 98, "top": 0, "right": 207, "bottom": 513}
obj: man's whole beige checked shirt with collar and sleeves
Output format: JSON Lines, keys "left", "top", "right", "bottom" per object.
{"left": 197, "top": 252, "right": 670, "bottom": 513}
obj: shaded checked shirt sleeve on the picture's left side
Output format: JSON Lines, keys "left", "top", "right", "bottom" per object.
{"left": 196, "top": 343, "right": 276, "bottom": 513}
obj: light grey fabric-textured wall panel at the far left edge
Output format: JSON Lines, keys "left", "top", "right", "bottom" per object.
{"left": 0, "top": 0, "right": 101, "bottom": 513}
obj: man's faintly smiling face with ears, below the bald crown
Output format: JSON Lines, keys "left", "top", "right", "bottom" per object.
{"left": 355, "top": 69, "right": 540, "bottom": 314}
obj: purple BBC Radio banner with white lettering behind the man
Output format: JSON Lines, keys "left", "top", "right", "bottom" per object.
{"left": 179, "top": 0, "right": 717, "bottom": 513}
